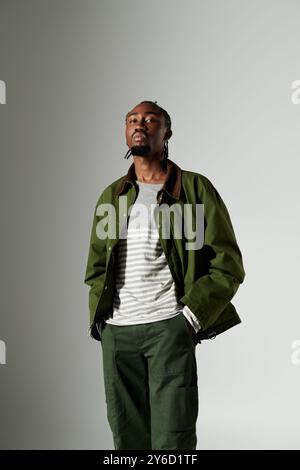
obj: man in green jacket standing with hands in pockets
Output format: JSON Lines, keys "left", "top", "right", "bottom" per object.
{"left": 85, "top": 101, "right": 245, "bottom": 450}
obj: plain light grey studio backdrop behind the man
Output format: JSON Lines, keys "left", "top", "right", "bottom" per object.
{"left": 0, "top": 0, "right": 300, "bottom": 449}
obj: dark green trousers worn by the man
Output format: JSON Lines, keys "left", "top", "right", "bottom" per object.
{"left": 100, "top": 312, "right": 198, "bottom": 450}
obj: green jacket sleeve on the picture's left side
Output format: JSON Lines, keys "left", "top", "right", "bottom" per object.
{"left": 84, "top": 195, "right": 106, "bottom": 339}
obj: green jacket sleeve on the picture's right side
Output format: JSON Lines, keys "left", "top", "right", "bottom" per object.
{"left": 180, "top": 175, "right": 245, "bottom": 330}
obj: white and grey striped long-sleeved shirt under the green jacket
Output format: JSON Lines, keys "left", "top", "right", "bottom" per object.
{"left": 106, "top": 181, "right": 200, "bottom": 331}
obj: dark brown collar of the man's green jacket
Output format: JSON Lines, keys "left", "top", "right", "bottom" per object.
{"left": 114, "top": 158, "right": 182, "bottom": 200}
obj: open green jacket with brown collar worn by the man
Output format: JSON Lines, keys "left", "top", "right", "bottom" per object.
{"left": 84, "top": 159, "right": 245, "bottom": 343}
